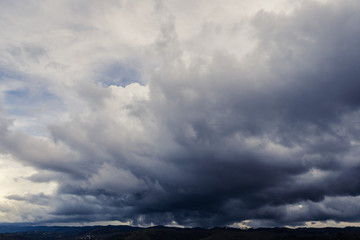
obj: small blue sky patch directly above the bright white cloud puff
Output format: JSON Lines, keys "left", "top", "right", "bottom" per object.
{"left": 96, "top": 62, "right": 142, "bottom": 87}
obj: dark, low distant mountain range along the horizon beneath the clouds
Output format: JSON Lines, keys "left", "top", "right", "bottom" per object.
{"left": 0, "top": 225, "right": 360, "bottom": 240}
